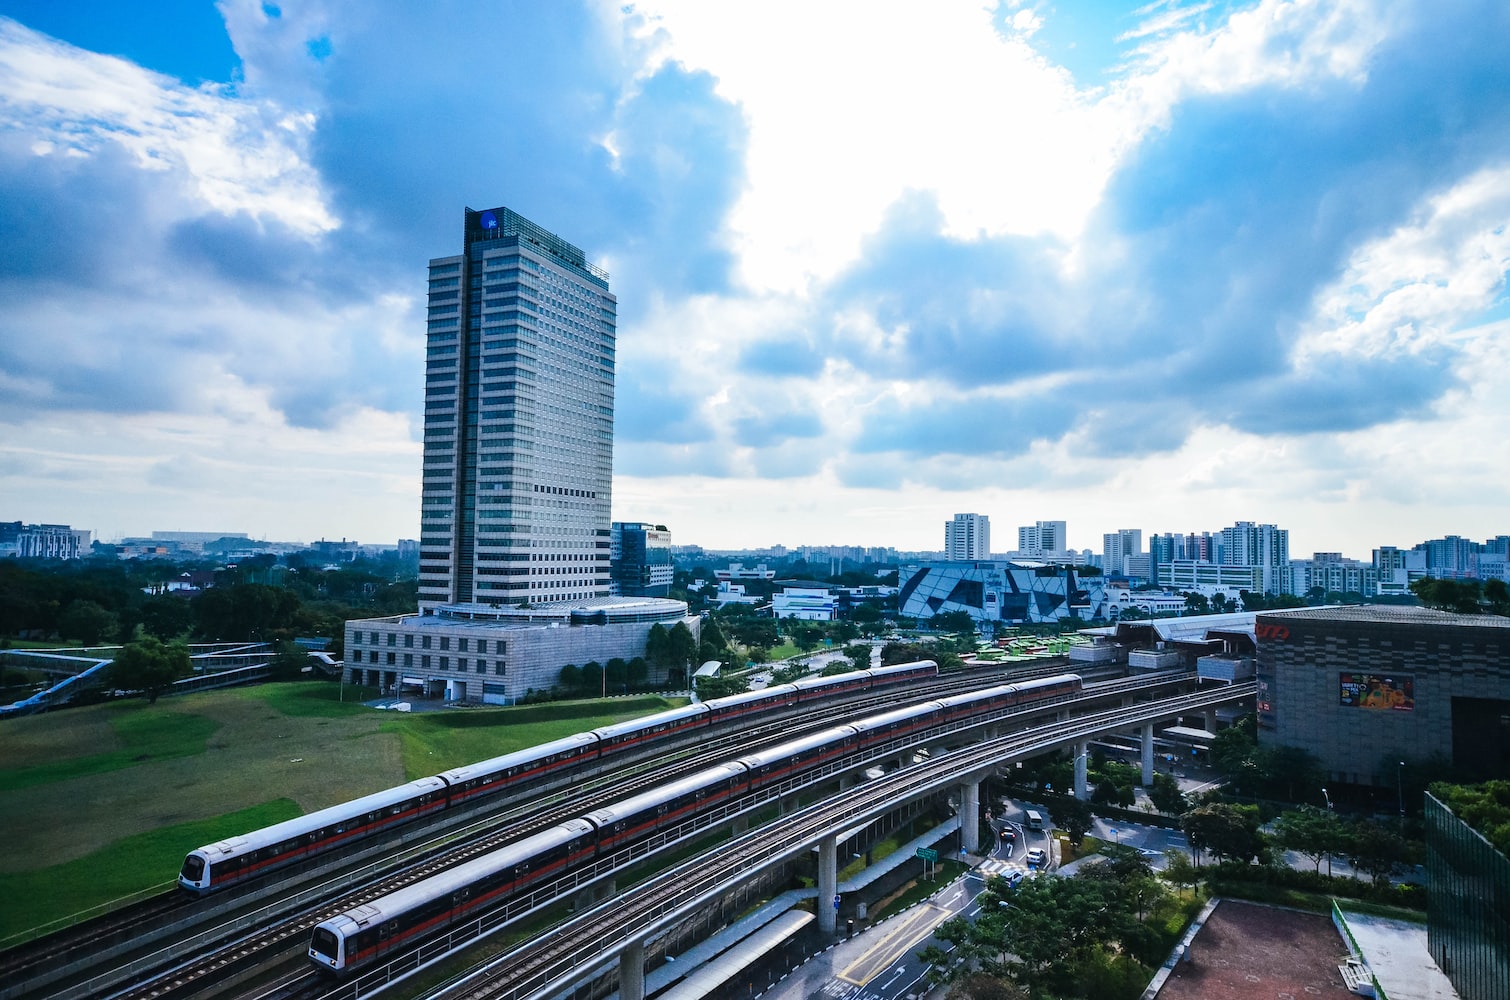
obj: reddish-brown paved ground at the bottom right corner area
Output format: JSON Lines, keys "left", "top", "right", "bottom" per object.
{"left": 1158, "top": 900, "right": 1353, "bottom": 1000}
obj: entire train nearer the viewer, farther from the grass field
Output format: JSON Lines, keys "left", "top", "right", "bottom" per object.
{"left": 308, "top": 674, "right": 1084, "bottom": 974}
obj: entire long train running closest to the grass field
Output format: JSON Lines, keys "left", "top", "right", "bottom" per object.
{"left": 178, "top": 660, "right": 938, "bottom": 896}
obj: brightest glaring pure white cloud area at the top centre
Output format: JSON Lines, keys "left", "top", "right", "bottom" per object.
{"left": 625, "top": 0, "right": 1110, "bottom": 292}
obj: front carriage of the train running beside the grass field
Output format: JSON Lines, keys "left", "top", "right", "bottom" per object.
{"left": 178, "top": 778, "right": 445, "bottom": 896}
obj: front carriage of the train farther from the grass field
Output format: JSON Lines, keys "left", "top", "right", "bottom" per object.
{"left": 308, "top": 819, "right": 593, "bottom": 973}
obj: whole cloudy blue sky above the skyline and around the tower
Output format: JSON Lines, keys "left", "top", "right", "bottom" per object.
{"left": 0, "top": 0, "right": 1510, "bottom": 557}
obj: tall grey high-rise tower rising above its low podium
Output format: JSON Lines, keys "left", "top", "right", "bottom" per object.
{"left": 420, "top": 208, "right": 618, "bottom": 607}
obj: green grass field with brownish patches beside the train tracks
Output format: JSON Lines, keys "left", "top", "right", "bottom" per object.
{"left": 0, "top": 681, "right": 675, "bottom": 938}
